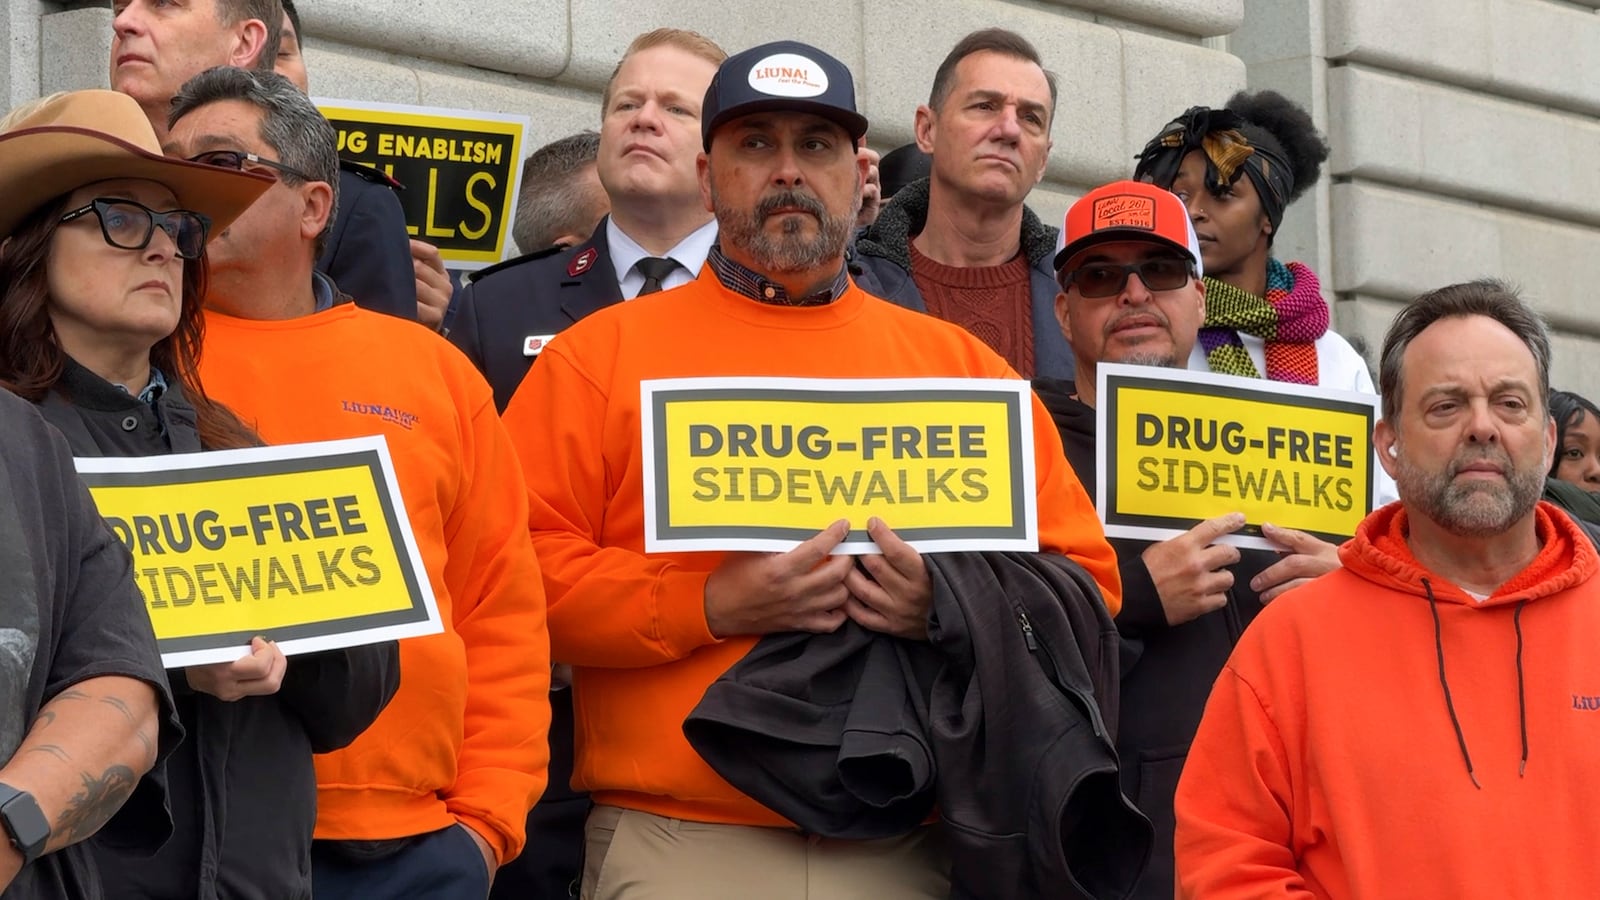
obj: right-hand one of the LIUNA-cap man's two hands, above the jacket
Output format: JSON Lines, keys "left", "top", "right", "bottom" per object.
{"left": 845, "top": 516, "right": 933, "bottom": 641}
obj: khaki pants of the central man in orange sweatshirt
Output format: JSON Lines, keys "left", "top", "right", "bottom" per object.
{"left": 582, "top": 806, "right": 950, "bottom": 900}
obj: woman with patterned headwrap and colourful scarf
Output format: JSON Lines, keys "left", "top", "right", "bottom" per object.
{"left": 1134, "top": 91, "right": 1373, "bottom": 394}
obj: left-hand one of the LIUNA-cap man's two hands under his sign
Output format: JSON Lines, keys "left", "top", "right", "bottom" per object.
{"left": 706, "top": 519, "right": 854, "bottom": 637}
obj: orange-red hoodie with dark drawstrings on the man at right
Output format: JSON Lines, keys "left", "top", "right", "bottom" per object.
{"left": 1178, "top": 503, "right": 1600, "bottom": 900}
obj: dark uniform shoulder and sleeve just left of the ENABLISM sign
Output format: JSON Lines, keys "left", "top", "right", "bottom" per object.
{"left": 317, "top": 160, "right": 416, "bottom": 320}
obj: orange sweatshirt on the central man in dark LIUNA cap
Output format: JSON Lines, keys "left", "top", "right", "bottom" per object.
{"left": 506, "top": 267, "right": 1120, "bottom": 825}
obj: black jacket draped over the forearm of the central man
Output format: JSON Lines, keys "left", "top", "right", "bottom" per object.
{"left": 683, "top": 552, "right": 1150, "bottom": 900}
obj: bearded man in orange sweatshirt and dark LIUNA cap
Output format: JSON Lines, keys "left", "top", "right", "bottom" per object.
{"left": 506, "top": 42, "right": 1120, "bottom": 900}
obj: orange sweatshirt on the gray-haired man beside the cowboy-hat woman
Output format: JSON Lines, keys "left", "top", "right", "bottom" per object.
{"left": 202, "top": 303, "right": 550, "bottom": 862}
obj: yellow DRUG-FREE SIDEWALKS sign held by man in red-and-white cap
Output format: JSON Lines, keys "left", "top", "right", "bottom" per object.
{"left": 1094, "top": 364, "right": 1378, "bottom": 549}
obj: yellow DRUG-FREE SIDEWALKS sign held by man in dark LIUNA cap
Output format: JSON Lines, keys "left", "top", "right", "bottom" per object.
{"left": 640, "top": 378, "right": 1038, "bottom": 554}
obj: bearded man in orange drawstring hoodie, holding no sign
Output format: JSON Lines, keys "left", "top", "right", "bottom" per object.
{"left": 1178, "top": 280, "right": 1600, "bottom": 900}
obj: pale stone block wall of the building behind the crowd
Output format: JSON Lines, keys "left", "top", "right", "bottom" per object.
{"left": 12, "top": 0, "right": 1600, "bottom": 397}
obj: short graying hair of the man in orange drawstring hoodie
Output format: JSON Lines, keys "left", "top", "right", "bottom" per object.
{"left": 1378, "top": 279, "right": 1550, "bottom": 421}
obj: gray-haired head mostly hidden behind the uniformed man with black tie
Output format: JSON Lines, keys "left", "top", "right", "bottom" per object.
{"left": 510, "top": 131, "right": 605, "bottom": 253}
